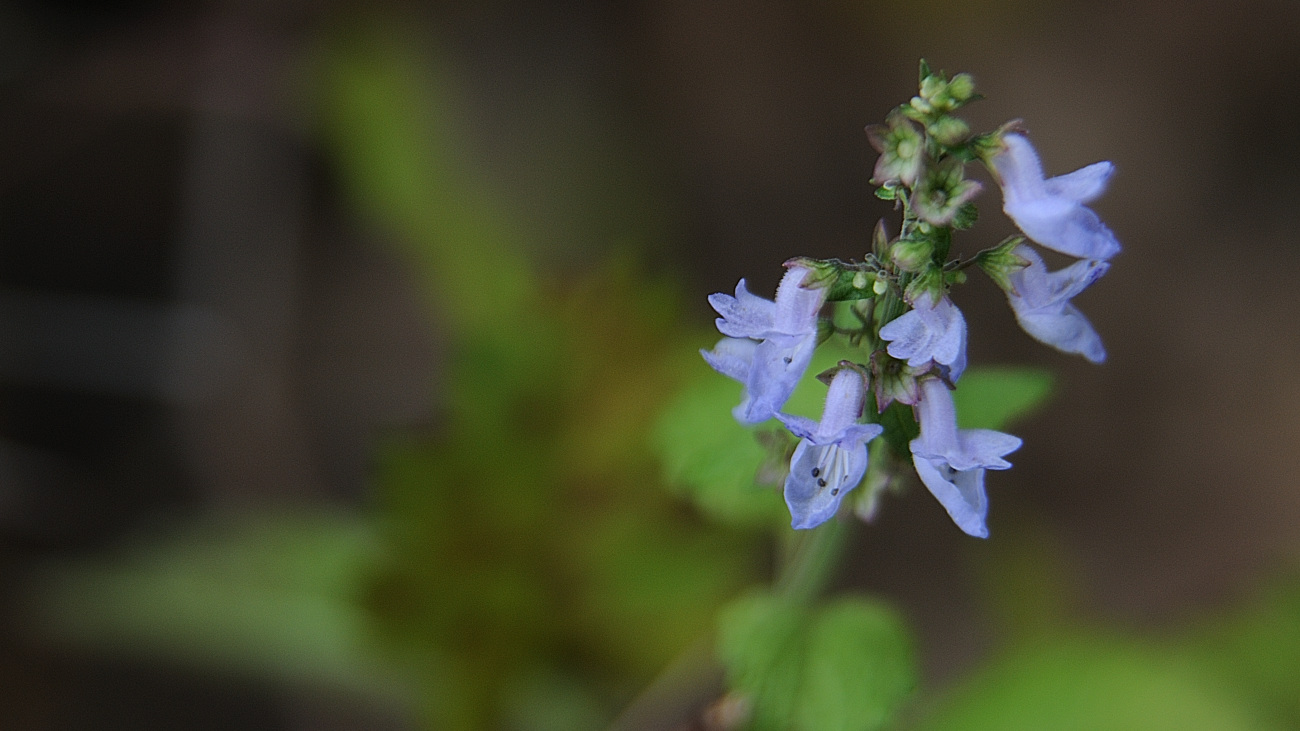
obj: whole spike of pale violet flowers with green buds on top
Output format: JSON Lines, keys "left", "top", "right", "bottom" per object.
{"left": 701, "top": 62, "right": 1119, "bottom": 537}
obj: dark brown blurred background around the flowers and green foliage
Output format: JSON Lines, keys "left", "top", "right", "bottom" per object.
{"left": 0, "top": 0, "right": 1300, "bottom": 730}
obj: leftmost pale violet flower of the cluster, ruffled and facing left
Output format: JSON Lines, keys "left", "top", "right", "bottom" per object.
{"left": 699, "top": 265, "right": 826, "bottom": 424}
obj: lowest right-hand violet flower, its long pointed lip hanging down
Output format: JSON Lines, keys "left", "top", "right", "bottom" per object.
{"left": 911, "top": 379, "right": 1021, "bottom": 538}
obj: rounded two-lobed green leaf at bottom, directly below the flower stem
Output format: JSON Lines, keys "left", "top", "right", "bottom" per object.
{"left": 719, "top": 594, "right": 917, "bottom": 731}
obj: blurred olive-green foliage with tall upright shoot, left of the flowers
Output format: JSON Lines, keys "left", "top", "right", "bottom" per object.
{"left": 317, "top": 19, "right": 758, "bottom": 728}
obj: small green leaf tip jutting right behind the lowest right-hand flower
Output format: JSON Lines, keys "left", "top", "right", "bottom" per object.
{"left": 953, "top": 367, "right": 1053, "bottom": 429}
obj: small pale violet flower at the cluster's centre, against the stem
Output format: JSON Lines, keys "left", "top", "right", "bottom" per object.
{"left": 880, "top": 291, "right": 966, "bottom": 381}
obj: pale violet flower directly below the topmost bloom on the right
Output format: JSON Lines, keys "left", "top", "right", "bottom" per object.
{"left": 1006, "top": 245, "right": 1110, "bottom": 363}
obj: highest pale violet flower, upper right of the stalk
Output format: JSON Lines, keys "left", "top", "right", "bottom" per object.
{"left": 992, "top": 134, "right": 1119, "bottom": 260}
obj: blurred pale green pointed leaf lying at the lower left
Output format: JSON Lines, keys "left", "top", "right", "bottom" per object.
{"left": 19, "top": 515, "right": 398, "bottom": 695}
